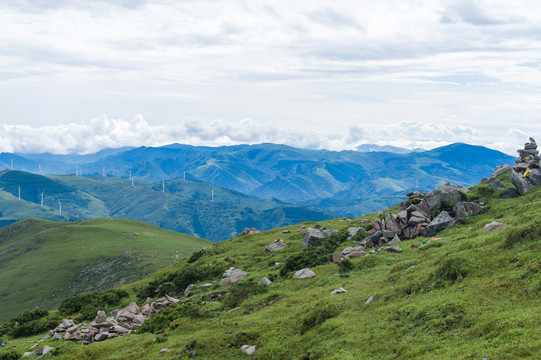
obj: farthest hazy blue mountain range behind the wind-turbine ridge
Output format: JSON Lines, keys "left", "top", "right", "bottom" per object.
{"left": 0, "top": 143, "right": 513, "bottom": 221}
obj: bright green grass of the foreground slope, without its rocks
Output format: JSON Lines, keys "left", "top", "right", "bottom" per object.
{"left": 3, "top": 167, "right": 541, "bottom": 359}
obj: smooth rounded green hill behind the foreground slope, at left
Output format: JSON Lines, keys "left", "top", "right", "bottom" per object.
{"left": 0, "top": 219, "right": 211, "bottom": 321}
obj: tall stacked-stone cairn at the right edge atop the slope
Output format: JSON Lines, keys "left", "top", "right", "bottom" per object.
{"left": 511, "top": 138, "right": 541, "bottom": 195}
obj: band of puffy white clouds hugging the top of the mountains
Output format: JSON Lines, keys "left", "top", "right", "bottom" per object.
{"left": 0, "top": 115, "right": 541, "bottom": 154}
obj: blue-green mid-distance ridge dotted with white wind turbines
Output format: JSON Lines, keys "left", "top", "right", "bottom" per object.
{"left": 0, "top": 170, "right": 330, "bottom": 241}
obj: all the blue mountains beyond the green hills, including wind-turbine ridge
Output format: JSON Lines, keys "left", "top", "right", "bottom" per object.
{"left": 0, "top": 143, "right": 514, "bottom": 240}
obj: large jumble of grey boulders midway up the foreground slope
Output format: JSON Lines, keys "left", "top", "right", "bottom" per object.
{"left": 302, "top": 183, "right": 485, "bottom": 261}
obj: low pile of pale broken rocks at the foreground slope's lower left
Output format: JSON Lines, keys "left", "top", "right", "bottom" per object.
{"left": 50, "top": 295, "right": 180, "bottom": 345}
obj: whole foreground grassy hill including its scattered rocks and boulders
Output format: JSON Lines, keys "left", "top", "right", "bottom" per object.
{"left": 0, "top": 142, "right": 541, "bottom": 360}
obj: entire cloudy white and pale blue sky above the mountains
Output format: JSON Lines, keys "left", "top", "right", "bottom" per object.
{"left": 0, "top": 0, "right": 541, "bottom": 154}
